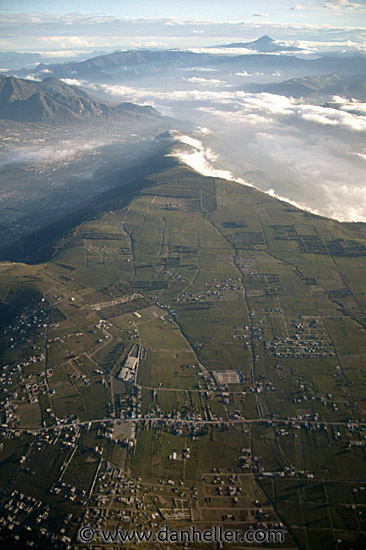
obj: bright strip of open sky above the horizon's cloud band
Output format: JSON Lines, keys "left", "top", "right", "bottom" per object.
{"left": 2, "top": 0, "right": 365, "bottom": 22}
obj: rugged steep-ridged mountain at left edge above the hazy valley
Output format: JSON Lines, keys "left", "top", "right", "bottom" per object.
{"left": 0, "top": 75, "right": 159, "bottom": 125}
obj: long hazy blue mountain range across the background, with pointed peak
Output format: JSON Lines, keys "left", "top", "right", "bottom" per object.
{"left": 8, "top": 40, "right": 365, "bottom": 85}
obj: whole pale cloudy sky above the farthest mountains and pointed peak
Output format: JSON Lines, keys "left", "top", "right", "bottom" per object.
{"left": 0, "top": 0, "right": 366, "bottom": 55}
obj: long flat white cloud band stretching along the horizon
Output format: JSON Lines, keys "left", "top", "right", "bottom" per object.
{"left": 0, "top": 12, "right": 365, "bottom": 53}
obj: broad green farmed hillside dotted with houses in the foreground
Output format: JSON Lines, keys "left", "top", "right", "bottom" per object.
{"left": 0, "top": 155, "right": 366, "bottom": 550}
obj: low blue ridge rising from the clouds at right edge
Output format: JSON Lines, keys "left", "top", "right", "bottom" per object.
{"left": 246, "top": 73, "right": 366, "bottom": 101}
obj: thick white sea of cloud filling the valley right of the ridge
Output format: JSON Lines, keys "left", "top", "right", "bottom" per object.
{"left": 85, "top": 75, "right": 366, "bottom": 221}
